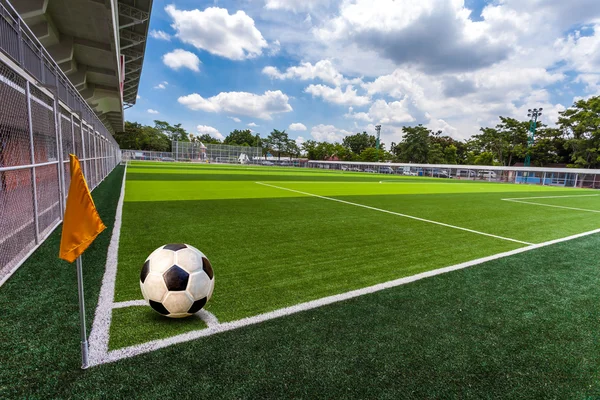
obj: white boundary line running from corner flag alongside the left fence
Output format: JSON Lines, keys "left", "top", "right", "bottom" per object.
{"left": 88, "top": 163, "right": 127, "bottom": 366}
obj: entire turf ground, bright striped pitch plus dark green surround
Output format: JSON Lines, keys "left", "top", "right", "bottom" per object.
{"left": 0, "top": 164, "right": 600, "bottom": 399}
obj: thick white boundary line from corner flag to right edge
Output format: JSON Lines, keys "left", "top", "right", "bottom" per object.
{"left": 90, "top": 229, "right": 600, "bottom": 366}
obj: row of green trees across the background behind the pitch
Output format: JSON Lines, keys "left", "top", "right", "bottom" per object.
{"left": 115, "top": 97, "right": 600, "bottom": 168}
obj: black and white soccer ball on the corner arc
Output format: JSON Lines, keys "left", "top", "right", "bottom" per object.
{"left": 140, "top": 243, "right": 215, "bottom": 318}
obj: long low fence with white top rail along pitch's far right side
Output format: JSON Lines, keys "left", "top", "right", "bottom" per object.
{"left": 308, "top": 161, "right": 600, "bottom": 189}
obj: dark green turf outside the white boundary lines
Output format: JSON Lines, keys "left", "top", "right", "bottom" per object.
{"left": 0, "top": 162, "right": 600, "bottom": 399}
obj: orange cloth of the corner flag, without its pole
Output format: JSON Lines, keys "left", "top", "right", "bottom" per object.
{"left": 58, "top": 154, "right": 106, "bottom": 262}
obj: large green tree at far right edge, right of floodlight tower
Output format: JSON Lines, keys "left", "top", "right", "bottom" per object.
{"left": 558, "top": 96, "right": 600, "bottom": 168}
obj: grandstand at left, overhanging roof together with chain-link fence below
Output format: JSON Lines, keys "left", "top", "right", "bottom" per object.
{"left": 0, "top": 0, "right": 152, "bottom": 283}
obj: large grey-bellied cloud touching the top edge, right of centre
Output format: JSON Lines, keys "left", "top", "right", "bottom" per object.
{"left": 315, "top": 0, "right": 512, "bottom": 73}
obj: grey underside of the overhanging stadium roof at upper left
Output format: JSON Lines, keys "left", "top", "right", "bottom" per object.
{"left": 11, "top": 0, "right": 152, "bottom": 132}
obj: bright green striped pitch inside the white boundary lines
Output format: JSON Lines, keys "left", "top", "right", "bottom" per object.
{"left": 104, "top": 163, "right": 600, "bottom": 359}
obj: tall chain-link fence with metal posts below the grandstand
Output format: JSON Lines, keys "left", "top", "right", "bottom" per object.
{"left": 0, "top": 1, "right": 121, "bottom": 284}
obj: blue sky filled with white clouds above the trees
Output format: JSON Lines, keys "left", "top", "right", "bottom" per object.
{"left": 126, "top": 0, "right": 600, "bottom": 147}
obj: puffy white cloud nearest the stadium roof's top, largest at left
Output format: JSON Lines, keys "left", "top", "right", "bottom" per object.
{"left": 165, "top": 5, "right": 268, "bottom": 60}
